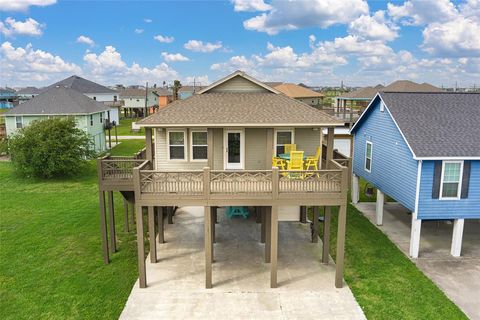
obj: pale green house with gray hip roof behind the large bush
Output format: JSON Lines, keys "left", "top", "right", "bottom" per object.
{"left": 5, "top": 86, "right": 110, "bottom": 151}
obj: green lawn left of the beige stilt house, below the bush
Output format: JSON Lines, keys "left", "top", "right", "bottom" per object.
{"left": 0, "top": 141, "right": 146, "bottom": 319}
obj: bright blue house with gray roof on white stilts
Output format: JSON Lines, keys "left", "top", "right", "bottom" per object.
{"left": 351, "top": 92, "right": 480, "bottom": 258}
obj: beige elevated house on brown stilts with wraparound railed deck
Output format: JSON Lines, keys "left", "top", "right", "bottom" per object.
{"left": 98, "top": 71, "right": 350, "bottom": 288}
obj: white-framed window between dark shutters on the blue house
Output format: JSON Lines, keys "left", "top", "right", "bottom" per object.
{"left": 440, "top": 161, "right": 463, "bottom": 199}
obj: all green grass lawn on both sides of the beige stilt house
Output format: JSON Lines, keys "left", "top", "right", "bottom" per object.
{"left": 0, "top": 140, "right": 466, "bottom": 319}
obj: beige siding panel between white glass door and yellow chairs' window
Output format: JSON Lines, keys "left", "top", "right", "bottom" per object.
{"left": 245, "top": 129, "right": 267, "bottom": 170}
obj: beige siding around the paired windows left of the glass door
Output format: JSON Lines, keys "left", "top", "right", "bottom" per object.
{"left": 155, "top": 129, "right": 207, "bottom": 170}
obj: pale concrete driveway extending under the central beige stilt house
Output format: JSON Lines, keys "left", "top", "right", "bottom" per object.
{"left": 120, "top": 207, "right": 365, "bottom": 320}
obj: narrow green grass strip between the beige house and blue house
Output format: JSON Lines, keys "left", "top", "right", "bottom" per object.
{"left": 320, "top": 204, "right": 468, "bottom": 319}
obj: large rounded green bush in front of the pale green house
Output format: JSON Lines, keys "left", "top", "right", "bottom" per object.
{"left": 8, "top": 118, "right": 95, "bottom": 178}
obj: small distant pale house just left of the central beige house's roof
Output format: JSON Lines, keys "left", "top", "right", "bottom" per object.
{"left": 119, "top": 88, "right": 159, "bottom": 117}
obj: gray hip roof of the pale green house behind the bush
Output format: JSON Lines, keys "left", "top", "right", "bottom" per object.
{"left": 5, "top": 87, "right": 110, "bottom": 115}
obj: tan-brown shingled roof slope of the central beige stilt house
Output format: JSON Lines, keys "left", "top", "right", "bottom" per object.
{"left": 138, "top": 92, "right": 343, "bottom": 126}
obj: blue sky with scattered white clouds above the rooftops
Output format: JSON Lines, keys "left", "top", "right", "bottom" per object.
{"left": 0, "top": 0, "right": 480, "bottom": 86}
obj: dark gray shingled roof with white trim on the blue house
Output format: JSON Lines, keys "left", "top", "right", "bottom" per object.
{"left": 351, "top": 92, "right": 480, "bottom": 159}
